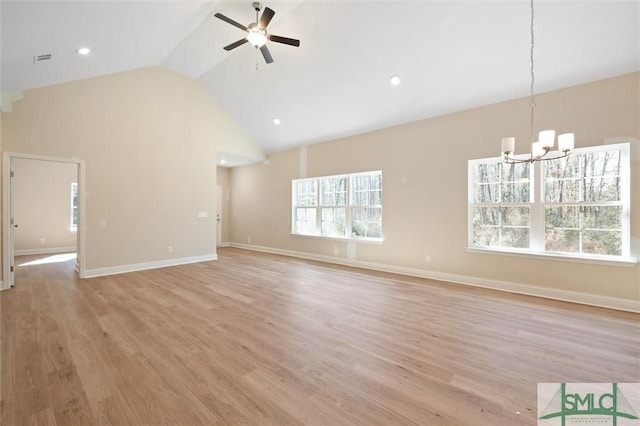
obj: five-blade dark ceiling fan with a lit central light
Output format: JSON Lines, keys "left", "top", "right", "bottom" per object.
{"left": 215, "top": 1, "right": 300, "bottom": 64}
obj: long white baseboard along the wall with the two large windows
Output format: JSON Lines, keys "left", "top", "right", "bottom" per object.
{"left": 230, "top": 243, "right": 640, "bottom": 313}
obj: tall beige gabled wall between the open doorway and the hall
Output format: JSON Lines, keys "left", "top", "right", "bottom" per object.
{"left": 2, "top": 67, "right": 264, "bottom": 270}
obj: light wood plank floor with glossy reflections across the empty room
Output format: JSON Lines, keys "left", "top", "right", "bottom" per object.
{"left": 0, "top": 248, "right": 640, "bottom": 426}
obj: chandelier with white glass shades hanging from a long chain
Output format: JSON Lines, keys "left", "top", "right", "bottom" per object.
{"left": 502, "top": 0, "right": 574, "bottom": 164}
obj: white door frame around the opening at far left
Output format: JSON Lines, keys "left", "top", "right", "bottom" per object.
{"left": 0, "top": 152, "right": 86, "bottom": 290}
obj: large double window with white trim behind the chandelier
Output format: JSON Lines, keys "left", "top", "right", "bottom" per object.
{"left": 469, "top": 144, "right": 630, "bottom": 259}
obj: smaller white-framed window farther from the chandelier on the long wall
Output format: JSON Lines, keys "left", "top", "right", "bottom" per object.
{"left": 292, "top": 171, "right": 382, "bottom": 240}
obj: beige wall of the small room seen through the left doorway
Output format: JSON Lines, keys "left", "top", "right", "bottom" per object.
{"left": 12, "top": 158, "right": 78, "bottom": 254}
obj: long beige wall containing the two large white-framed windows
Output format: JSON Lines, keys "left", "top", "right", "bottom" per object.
{"left": 231, "top": 73, "right": 640, "bottom": 302}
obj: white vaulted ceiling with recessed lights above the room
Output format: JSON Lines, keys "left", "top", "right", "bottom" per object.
{"left": 0, "top": 0, "right": 640, "bottom": 153}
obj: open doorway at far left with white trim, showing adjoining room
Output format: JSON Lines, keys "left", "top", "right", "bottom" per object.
{"left": 2, "top": 153, "right": 84, "bottom": 289}
